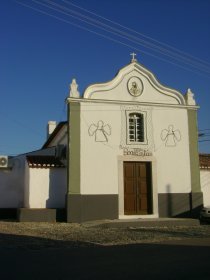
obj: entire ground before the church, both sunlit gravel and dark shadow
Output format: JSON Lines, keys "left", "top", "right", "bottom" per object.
{"left": 0, "top": 222, "right": 210, "bottom": 280}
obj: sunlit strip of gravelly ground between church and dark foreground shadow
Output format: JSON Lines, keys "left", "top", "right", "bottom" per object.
{"left": 0, "top": 222, "right": 210, "bottom": 247}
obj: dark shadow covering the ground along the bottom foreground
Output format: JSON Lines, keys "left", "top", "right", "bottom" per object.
{"left": 0, "top": 234, "right": 210, "bottom": 280}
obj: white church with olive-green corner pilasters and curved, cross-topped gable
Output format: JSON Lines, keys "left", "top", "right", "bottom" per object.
{"left": 66, "top": 53, "right": 203, "bottom": 222}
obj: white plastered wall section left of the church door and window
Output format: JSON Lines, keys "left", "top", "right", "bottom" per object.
{"left": 81, "top": 103, "right": 121, "bottom": 194}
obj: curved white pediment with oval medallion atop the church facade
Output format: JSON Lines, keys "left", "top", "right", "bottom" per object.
{"left": 83, "top": 62, "right": 186, "bottom": 105}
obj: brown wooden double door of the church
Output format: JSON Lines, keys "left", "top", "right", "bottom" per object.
{"left": 124, "top": 162, "right": 152, "bottom": 215}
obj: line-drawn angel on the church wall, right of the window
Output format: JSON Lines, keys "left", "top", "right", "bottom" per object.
{"left": 160, "top": 125, "right": 181, "bottom": 147}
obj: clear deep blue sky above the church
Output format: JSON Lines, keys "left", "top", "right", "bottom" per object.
{"left": 0, "top": 0, "right": 210, "bottom": 155}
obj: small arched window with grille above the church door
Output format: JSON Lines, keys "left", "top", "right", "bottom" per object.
{"left": 128, "top": 113, "right": 145, "bottom": 144}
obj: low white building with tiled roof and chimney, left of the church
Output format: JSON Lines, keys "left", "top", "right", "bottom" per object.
{"left": 0, "top": 122, "right": 67, "bottom": 222}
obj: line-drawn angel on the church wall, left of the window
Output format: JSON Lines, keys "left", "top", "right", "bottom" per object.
{"left": 88, "top": 120, "right": 111, "bottom": 142}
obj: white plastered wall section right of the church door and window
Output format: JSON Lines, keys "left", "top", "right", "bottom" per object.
{"left": 152, "top": 107, "right": 191, "bottom": 193}
